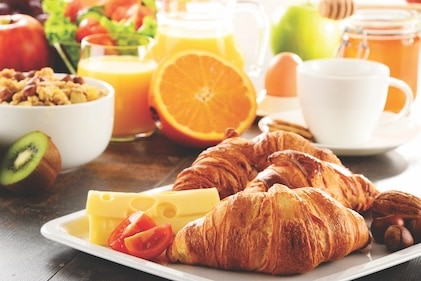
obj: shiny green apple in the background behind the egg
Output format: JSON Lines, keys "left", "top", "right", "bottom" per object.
{"left": 270, "top": 3, "right": 342, "bottom": 60}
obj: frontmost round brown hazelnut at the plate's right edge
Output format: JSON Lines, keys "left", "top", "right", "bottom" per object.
{"left": 384, "top": 225, "right": 414, "bottom": 252}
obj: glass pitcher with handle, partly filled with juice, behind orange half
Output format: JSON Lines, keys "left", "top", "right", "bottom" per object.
{"left": 154, "top": 0, "right": 269, "bottom": 76}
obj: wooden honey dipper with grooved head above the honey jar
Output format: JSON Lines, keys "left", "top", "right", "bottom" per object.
{"left": 319, "top": 0, "right": 421, "bottom": 20}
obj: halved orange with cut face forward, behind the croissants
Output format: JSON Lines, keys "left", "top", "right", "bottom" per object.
{"left": 149, "top": 50, "right": 257, "bottom": 148}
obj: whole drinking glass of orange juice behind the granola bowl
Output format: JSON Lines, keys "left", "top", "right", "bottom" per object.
{"left": 77, "top": 34, "right": 157, "bottom": 142}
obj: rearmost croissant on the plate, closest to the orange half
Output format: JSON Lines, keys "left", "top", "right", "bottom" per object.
{"left": 173, "top": 130, "right": 341, "bottom": 198}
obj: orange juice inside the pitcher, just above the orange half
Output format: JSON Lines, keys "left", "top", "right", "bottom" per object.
{"left": 153, "top": 27, "right": 245, "bottom": 68}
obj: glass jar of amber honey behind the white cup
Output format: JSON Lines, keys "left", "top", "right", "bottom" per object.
{"left": 338, "top": 8, "right": 420, "bottom": 112}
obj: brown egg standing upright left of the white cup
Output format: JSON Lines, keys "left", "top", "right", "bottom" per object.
{"left": 264, "top": 52, "right": 302, "bottom": 97}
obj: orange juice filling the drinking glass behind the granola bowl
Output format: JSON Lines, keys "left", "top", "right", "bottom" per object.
{"left": 77, "top": 56, "right": 156, "bottom": 139}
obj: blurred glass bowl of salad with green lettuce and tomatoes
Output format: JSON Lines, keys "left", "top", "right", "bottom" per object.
{"left": 42, "top": 0, "right": 157, "bottom": 74}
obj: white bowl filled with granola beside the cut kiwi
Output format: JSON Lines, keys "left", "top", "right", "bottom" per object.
{"left": 0, "top": 68, "right": 114, "bottom": 172}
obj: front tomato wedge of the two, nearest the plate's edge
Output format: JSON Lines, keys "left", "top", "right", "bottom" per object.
{"left": 124, "top": 224, "right": 173, "bottom": 259}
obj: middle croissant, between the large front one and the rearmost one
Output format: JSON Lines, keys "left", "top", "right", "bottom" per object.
{"left": 246, "top": 150, "right": 379, "bottom": 212}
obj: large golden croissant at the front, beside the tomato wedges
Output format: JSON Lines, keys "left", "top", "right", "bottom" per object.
{"left": 166, "top": 184, "right": 370, "bottom": 275}
